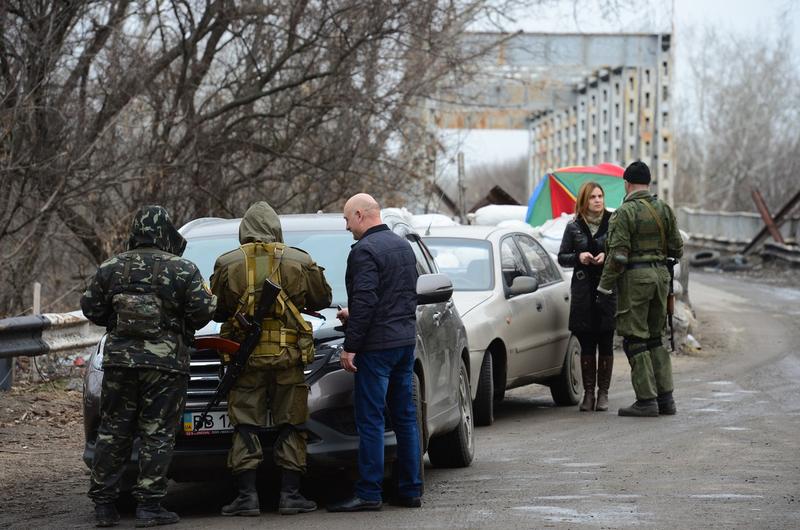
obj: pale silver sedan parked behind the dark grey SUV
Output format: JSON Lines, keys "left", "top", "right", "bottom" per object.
{"left": 423, "top": 226, "right": 582, "bottom": 425}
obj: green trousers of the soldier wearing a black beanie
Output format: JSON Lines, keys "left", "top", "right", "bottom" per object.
{"left": 616, "top": 267, "right": 673, "bottom": 400}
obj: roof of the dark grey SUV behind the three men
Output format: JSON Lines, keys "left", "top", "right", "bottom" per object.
{"left": 179, "top": 213, "right": 416, "bottom": 239}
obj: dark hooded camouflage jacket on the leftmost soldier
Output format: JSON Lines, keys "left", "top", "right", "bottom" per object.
{"left": 81, "top": 206, "right": 216, "bottom": 373}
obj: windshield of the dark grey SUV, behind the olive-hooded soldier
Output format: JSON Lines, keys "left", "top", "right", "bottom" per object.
{"left": 183, "top": 230, "right": 354, "bottom": 305}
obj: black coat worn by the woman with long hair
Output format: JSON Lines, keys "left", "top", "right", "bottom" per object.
{"left": 558, "top": 211, "right": 617, "bottom": 333}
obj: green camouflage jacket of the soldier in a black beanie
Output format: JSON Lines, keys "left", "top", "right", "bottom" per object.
{"left": 598, "top": 190, "right": 683, "bottom": 292}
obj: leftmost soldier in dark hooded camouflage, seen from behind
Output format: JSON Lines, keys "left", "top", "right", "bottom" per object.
{"left": 81, "top": 206, "right": 216, "bottom": 526}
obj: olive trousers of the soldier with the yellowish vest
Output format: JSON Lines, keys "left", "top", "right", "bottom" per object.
{"left": 228, "top": 365, "right": 308, "bottom": 474}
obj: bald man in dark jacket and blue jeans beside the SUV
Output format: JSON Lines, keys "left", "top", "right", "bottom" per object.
{"left": 328, "top": 193, "right": 422, "bottom": 512}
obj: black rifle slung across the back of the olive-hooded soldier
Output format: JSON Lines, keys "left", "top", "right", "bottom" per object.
{"left": 194, "top": 278, "right": 281, "bottom": 432}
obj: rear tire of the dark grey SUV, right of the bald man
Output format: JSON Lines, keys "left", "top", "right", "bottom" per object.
{"left": 428, "top": 360, "right": 475, "bottom": 467}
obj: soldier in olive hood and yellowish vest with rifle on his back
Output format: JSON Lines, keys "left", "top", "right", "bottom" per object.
{"left": 211, "top": 202, "right": 331, "bottom": 516}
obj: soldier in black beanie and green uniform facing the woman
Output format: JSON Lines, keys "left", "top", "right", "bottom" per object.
{"left": 597, "top": 161, "right": 683, "bottom": 416}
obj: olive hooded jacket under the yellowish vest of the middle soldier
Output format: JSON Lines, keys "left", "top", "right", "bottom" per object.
{"left": 211, "top": 202, "right": 332, "bottom": 352}
